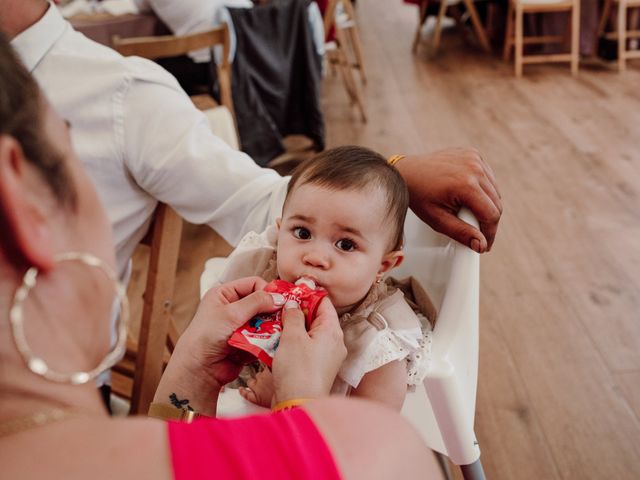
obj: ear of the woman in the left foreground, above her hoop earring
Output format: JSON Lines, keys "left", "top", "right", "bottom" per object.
{"left": 0, "top": 135, "right": 54, "bottom": 271}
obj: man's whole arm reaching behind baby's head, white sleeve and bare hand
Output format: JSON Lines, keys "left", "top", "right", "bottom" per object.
{"left": 123, "top": 59, "right": 502, "bottom": 252}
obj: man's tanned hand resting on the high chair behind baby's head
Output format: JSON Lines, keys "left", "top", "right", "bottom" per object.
{"left": 395, "top": 149, "right": 502, "bottom": 253}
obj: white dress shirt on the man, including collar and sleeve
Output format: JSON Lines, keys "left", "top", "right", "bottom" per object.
{"left": 11, "top": 6, "right": 287, "bottom": 277}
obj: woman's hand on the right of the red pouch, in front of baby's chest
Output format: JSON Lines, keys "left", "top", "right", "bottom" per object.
{"left": 273, "top": 297, "right": 347, "bottom": 402}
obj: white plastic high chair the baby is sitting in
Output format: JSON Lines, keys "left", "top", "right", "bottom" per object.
{"left": 200, "top": 209, "right": 485, "bottom": 480}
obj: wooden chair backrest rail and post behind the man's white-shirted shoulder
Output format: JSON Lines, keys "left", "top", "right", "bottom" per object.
{"left": 112, "top": 23, "right": 235, "bottom": 118}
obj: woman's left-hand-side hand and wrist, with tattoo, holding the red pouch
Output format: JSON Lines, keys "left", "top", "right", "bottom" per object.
{"left": 154, "top": 277, "right": 284, "bottom": 416}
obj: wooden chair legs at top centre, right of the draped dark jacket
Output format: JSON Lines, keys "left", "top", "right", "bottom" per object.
{"left": 323, "top": 0, "right": 367, "bottom": 123}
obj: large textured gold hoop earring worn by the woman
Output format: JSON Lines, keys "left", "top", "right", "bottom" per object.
{"left": 9, "top": 252, "right": 129, "bottom": 385}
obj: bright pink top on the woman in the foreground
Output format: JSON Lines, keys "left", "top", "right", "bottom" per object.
{"left": 168, "top": 408, "right": 340, "bottom": 480}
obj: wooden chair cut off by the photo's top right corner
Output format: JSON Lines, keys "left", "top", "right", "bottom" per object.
{"left": 594, "top": 0, "right": 640, "bottom": 72}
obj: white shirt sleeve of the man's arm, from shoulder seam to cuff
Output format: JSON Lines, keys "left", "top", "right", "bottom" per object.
{"left": 120, "top": 58, "right": 288, "bottom": 245}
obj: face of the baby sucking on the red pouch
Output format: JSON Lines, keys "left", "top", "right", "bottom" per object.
{"left": 277, "top": 184, "right": 395, "bottom": 314}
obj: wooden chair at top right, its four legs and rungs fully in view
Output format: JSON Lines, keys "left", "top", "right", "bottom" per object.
{"left": 503, "top": 0, "right": 580, "bottom": 77}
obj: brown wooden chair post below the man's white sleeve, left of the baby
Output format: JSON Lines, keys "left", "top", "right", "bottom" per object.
{"left": 112, "top": 203, "right": 182, "bottom": 414}
